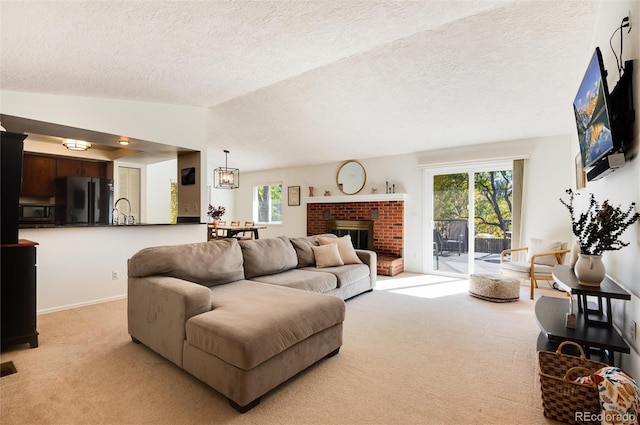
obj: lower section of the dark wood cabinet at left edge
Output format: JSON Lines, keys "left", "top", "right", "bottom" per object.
{"left": 0, "top": 239, "right": 38, "bottom": 349}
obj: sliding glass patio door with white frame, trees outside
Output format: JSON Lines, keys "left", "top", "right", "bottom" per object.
{"left": 424, "top": 162, "right": 513, "bottom": 276}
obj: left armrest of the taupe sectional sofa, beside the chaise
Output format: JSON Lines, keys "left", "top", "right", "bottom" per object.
{"left": 127, "top": 276, "right": 211, "bottom": 367}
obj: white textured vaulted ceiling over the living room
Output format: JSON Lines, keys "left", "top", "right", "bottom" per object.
{"left": 0, "top": 0, "right": 599, "bottom": 170}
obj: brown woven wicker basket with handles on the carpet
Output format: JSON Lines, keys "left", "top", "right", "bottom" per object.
{"left": 538, "top": 341, "right": 609, "bottom": 424}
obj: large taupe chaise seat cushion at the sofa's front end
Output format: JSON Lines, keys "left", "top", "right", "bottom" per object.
{"left": 186, "top": 280, "right": 345, "bottom": 370}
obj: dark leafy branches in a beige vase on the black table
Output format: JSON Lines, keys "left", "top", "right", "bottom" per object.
{"left": 560, "top": 189, "right": 640, "bottom": 286}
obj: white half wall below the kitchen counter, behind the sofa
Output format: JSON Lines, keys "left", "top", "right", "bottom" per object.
{"left": 19, "top": 224, "right": 206, "bottom": 313}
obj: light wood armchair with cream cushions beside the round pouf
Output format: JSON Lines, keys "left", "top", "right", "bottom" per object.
{"left": 500, "top": 238, "right": 570, "bottom": 299}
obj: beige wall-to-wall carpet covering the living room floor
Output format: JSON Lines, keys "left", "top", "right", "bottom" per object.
{"left": 0, "top": 274, "right": 562, "bottom": 425}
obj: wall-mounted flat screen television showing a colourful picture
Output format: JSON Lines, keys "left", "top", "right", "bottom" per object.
{"left": 573, "top": 47, "right": 620, "bottom": 170}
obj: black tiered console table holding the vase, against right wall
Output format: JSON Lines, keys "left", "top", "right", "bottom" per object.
{"left": 535, "top": 265, "right": 631, "bottom": 365}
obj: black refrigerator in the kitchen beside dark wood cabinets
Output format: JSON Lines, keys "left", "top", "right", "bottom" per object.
{"left": 55, "top": 177, "right": 113, "bottom": 224}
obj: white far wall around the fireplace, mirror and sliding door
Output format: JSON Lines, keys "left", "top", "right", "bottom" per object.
{"left": 239, "top": 135, "right": 577, "bottom": 273}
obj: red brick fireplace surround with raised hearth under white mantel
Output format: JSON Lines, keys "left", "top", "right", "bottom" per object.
{"left": 307, "top": 196, "right": 404, "bottom": 276}
